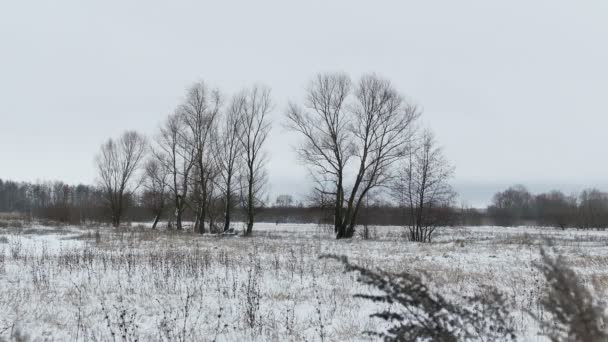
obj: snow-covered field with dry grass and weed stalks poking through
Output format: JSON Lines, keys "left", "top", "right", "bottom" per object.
{"left": 0, "top": 220, "right": 608, "bottom": 341}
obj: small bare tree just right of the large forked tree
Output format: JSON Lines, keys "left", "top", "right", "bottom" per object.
{"left": 392, "top": 131, "right": 456, "bottom": 242}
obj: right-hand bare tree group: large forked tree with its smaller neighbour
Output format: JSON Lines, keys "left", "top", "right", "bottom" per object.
{"left": 287, "top": 73, "right": 454, "bottom": 242}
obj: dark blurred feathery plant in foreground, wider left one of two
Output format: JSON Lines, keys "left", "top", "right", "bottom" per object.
{"left": 321, "top": 255, "right": 515, "bottom": 342}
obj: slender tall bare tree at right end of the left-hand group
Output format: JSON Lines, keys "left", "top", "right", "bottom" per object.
{"left": 239, "top": 86, "right": 272, "bottom": 235}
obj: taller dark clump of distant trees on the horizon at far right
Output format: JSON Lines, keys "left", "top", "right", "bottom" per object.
{"left": 487, "top": 185, "right": 608, "bottom": 229}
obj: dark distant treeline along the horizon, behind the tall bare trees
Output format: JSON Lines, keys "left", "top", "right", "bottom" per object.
{"left": 0, "top": 179, "right": 608, "bottom": 229}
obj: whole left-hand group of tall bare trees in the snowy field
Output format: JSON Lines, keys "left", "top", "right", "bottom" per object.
{"left": 96, "top": 82, "right": 272, "bottom": 235}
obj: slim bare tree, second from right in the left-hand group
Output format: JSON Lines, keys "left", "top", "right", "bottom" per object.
{"left": 214, "top": 94, "right": 247, "bottom": 232}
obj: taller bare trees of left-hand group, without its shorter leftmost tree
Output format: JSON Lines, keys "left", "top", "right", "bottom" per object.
{"left": 148, "top": 82, "right": 272, "bottom": 233}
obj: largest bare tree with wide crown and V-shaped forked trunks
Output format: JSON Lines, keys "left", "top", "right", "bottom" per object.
{"left": 287, "top": 74, "right": 419, "bottom": 239}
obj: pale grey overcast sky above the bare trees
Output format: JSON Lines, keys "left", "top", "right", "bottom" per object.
{"left": 0, "top": 0, "right": 608, "bottom": 205}
